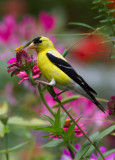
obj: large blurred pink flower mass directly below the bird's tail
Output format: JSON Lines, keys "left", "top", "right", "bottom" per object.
{"left": 65, "top": 92, "right": 108, "bottom": 126}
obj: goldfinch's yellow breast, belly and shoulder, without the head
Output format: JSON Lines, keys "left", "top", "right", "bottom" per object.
{"left": 37, "top": 50, "right": 72, "bottom": 89}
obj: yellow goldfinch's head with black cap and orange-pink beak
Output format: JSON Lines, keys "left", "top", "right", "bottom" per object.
{"left": 29, "top": 37, "right": 54, "bottom": 52}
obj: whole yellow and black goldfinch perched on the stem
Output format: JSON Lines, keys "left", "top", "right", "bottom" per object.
{"left": 29, "top": 36, "right": 104, "bottom": 112}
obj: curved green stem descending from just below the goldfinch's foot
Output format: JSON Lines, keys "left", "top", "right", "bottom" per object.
{"left": 38, "top": 85, "right": 55, "bottom": 117}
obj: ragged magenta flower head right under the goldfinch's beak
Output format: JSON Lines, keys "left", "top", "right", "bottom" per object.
{"left": 7, "top": 47, "right": 41, "bottom": 84}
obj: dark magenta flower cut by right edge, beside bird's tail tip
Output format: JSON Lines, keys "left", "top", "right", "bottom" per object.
{"left": 107, "top": 96, "right": 115, "bottom": 115}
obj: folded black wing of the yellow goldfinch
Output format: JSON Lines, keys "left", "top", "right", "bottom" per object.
{"left": 47, "top": 53, "right": 97, "bottom": 94}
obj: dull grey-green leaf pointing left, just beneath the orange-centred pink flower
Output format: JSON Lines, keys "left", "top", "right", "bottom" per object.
{"left": 40, "top": 139, "right": 63, "bottom": 148}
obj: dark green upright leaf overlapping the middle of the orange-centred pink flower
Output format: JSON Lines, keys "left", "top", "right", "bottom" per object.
{"left": 64, "top": 124, "right": 75, "bottom": 142}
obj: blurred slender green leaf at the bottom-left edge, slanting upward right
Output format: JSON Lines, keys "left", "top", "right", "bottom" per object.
{"left": 0, "top": 141, "right": 30, "bottom": 153}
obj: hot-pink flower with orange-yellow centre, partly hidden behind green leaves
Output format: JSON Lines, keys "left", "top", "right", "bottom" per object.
{"left": 49, "top": 119, "right": 87, "bottom": 139}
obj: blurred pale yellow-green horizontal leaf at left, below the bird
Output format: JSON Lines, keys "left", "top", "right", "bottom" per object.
{"left": 8, "top": 116, "right": 48, "bottom": 127}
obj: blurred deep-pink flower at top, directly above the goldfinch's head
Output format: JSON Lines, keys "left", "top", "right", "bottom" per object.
{"left": 39, "top": 11, "right": 57, "bottom": 32}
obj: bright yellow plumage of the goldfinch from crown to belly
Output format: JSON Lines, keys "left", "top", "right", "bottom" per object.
{"left": 37, "top": 38, "right": 72, "bottom": 89}
